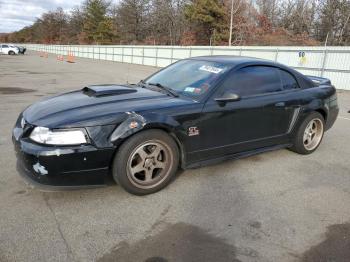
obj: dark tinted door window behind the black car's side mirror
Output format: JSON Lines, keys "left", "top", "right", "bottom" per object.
{"left": 223, "top": 66, "right": 282, "bottom": 96}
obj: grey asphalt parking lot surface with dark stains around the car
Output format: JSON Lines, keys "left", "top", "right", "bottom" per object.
{"left": 0, "top": 52, "right": 350, "bottom": 262}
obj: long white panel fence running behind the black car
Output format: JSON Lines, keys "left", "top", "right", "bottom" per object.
{"left": 25, "top": 44, "right": 350, "bottom": 90}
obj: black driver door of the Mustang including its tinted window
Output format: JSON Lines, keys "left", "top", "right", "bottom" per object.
{"left": 195, "top": 66, "right": 297, "bottom": 160}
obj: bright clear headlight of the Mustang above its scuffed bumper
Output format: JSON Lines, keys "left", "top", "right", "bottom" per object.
{"left": 29, "top": 127, "right": 87, "bottom": 145}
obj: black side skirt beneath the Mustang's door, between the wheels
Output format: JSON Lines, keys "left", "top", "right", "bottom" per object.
{"left": 184, "top": 144, "right": 292, "bottom": 169}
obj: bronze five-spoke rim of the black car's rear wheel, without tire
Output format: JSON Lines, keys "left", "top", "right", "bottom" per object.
{"left": 303, "top": 118, "right": 323, "bottom": 151}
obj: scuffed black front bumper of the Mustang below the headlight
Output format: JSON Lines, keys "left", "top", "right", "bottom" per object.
{"left": 12, "top": 127, "right": 115, "bottom": 191}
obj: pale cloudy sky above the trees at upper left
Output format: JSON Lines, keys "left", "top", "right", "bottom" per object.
{"left": 0, "top": 0, "right": 83, "bottom": 33}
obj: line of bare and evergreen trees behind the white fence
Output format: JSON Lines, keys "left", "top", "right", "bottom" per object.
{"left": 0, "top": 0, "right": 350, "bottom": 45}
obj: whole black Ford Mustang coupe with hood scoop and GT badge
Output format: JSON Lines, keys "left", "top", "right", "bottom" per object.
{"left": 13, "top": 56, "right": 339, "bottom": 195}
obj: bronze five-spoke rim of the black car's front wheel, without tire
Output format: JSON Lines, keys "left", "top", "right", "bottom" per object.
{"left": 127, "top": 140, "right": 173, "bottom": 189}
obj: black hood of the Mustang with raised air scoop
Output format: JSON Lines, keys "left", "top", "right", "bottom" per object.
{"left": 23, "top": 85, "right": 193, "bottom": 128}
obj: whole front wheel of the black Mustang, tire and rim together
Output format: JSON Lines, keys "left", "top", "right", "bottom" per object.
{"left": 112, "top": 129, "right": 179, "bottom": 195}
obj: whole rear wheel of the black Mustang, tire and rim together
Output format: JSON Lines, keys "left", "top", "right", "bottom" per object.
{"left": 291, "top": 112, "right": 325, "bottom": 155}
